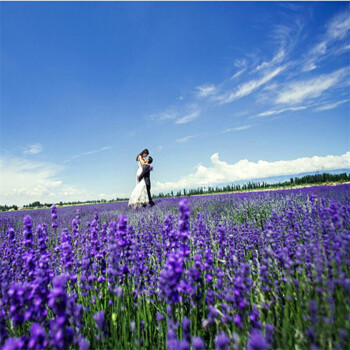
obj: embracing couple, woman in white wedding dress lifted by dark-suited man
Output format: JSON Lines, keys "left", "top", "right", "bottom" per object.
{"left": 129, "top": 149, "right": 154, "bottom": 209}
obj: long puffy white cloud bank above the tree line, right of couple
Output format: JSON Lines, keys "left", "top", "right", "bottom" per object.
{"left": 153, "top": 152, "right": 350, "bottom": 192}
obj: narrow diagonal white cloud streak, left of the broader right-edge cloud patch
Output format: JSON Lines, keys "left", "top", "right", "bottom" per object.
{"left": 213, "top": 66, "right": 285, "bottom": 104}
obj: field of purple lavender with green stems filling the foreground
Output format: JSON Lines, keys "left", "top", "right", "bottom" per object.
{"left": 0, "top": 184, "right": 350, "bottom": 350}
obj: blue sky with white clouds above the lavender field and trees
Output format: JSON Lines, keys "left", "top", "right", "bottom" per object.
{"left": 0, "top": 2, "right": 350, "bottom": 205}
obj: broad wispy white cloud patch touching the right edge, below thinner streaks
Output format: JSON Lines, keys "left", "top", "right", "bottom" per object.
{"left": 276, "top": 68, "right": 348, "bottom": 104}
